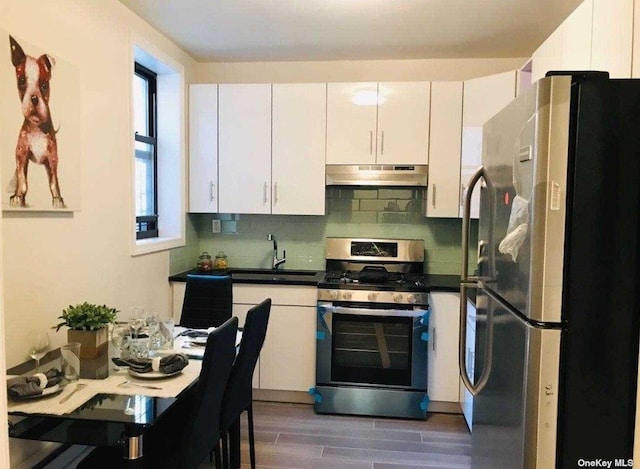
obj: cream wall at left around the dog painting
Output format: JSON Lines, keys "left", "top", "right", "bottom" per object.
{"left": 0, "top": 0, "right": 195, "bottom": 467}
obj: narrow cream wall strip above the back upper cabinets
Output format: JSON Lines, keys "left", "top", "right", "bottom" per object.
{"left": 194, "top": 58, "right": 527, "bottom": 83}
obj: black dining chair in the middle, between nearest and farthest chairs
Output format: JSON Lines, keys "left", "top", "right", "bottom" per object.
{"left": 220, "top": 298, "right": 271, "bottom": 469}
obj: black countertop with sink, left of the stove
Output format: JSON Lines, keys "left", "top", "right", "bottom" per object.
{"left": 169, "top": 268, "right": 324, "bottom": 286}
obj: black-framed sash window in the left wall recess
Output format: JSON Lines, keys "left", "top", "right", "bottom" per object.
{"left": 133, "top": 62, "right": 158, "bottom": 239}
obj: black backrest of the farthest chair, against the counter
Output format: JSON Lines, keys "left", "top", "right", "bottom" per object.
{"left": 180, "top": 274, "right": 233, "bottom": 329}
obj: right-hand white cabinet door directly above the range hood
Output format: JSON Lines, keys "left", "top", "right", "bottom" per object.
{"left": 376, "top": 82, "right": 431, "bottom": 165}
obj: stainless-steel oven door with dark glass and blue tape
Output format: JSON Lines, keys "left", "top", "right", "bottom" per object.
{"left": 316, "top": 303, "right": 429, "bottom": 390}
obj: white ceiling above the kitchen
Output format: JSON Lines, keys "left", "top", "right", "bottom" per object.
{"left": 120, "top": 0, "right": 582, "bottom": 62}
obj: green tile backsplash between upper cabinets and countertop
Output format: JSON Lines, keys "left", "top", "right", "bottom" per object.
{"left": 170, "top": 187, "right": 477, "bottom": 274}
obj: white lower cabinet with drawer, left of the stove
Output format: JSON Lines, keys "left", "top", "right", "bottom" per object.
{"left": 233, "top": 284, "right": 318, "bottom": 391}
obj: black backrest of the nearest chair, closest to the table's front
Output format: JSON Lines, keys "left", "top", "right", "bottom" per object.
{"left": 179, "top": 317, "right": 238, "bottom": 469}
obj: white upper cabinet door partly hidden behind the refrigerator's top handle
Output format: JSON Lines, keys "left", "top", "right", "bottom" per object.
{"left": 460, "top": 71, "right": 516, "bottom": 218}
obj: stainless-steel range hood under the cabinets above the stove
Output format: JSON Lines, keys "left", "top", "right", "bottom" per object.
{"left": 327, "top": 164, "right": 428, "bottom": 187}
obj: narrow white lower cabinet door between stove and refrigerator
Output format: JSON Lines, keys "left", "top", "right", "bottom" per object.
{"left": 427, "top": 292, "right": 460, "bottom": 402}
